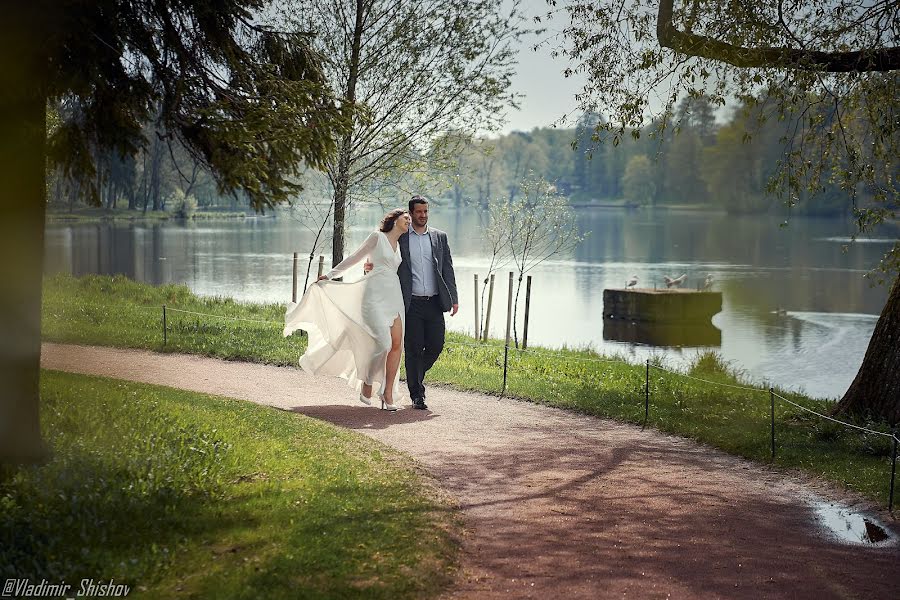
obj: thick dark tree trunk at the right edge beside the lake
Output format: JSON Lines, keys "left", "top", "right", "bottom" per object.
{"left": 834, "top": 276, "right": 900, "bottom": 425}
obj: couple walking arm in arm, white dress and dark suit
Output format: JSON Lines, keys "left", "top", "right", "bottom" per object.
{"left": 284, "top": 196, "right": 459, "bottom": 411}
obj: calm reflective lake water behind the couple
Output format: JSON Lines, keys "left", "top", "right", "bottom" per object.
{"left": 45, "top": 207, "right": 900, "bottom": 398}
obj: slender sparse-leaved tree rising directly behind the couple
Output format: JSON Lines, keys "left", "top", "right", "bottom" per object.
{"left": 283, "top": 0, "right": 520, "bottom": 264}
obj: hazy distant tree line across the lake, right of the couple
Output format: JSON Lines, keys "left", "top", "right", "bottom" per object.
{"left": 426, "top": 92, "right": 884, "bottom": 216}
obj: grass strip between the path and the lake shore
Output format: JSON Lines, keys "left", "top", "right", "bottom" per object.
{"left": 43, "top": 276, "right": 896, "bottom": 505}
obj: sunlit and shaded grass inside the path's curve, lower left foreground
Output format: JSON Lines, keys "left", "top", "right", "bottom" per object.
{"left": 0, "top": 371, "right": 458, "bottom": 598}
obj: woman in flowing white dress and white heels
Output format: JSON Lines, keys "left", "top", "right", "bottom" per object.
{"left": 284, "top": 208, "right": 410, "bottom": 411}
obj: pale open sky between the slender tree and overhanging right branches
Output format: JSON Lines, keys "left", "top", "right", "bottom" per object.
{"left": 501, "top": 0, "right": 584, "bottom": 133}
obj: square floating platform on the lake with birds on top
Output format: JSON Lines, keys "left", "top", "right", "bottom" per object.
{"left": 603, "top": 288, "right": 722, "bottom": 323}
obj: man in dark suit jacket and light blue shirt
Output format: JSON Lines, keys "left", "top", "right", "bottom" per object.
{"left": 397, "top": 195, "right": 459, "bottom": 409}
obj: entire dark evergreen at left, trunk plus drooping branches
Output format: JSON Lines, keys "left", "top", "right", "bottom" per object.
{"left": 0, "top": 0, "right": 341, "bottom": 461}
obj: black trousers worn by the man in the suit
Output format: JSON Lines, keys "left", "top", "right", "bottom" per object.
{"left": 403, "top": 296, "right": 445, "bottom": 398}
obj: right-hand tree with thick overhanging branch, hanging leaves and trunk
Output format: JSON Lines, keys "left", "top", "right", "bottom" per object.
{"left": 550, "top": 0, "right": 900, "bottom": 423}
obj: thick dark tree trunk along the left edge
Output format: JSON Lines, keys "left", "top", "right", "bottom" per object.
{"left": 0, "top": 2, "right": 47, "bottom": 463}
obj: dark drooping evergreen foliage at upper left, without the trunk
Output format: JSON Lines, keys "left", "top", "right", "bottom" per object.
{"left": 38, "top": 0, "right": 342, "bottom": 210}
